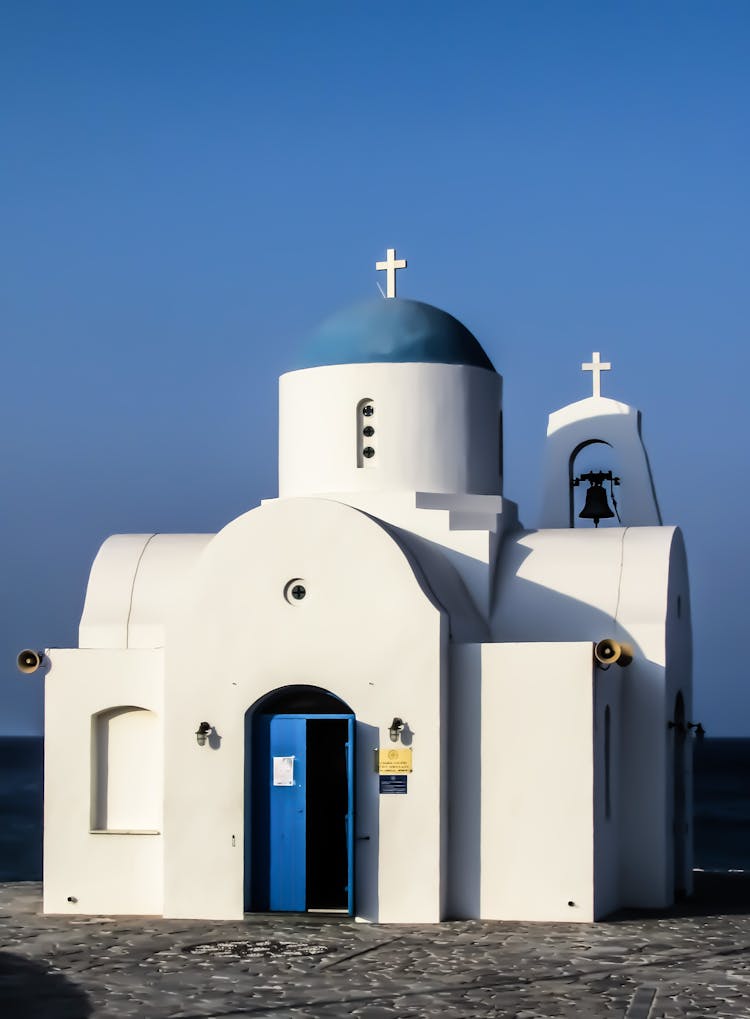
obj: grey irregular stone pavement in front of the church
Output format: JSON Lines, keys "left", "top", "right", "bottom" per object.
{"left": 0, "top": 882, "right": 750, "bottom": 1019}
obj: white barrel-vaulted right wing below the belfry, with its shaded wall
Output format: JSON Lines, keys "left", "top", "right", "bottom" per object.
{"left": 493, "top": 527, "right": 690, "bottom": 908}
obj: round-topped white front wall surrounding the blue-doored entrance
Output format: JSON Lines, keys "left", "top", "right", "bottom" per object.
{"left": 164, "top": 499, "right": 447, "bottom": 922}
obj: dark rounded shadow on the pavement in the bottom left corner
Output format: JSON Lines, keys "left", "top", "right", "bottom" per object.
{"left": 0, "top": 952, "right": 94, "bottom": 1019}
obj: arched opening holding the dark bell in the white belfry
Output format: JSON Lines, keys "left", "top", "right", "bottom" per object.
{"left": 568, "top": 439, "right": 621, "bottom": 527}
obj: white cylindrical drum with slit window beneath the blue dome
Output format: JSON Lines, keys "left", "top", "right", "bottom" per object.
{"left": 279, "top": 364, "right": 502, "bottom": 498}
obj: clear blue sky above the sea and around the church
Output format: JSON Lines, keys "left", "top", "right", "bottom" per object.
{"left": 0, "top": 0, "right": 750, "bottom": 736}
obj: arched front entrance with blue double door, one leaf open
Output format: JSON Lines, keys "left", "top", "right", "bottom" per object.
{"left": 245, "top": 686, "right": 355, "bottom": 913}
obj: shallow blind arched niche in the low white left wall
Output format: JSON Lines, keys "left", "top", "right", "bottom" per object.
{"left": 91, "top": 705, "right": 162, "bottom": 835}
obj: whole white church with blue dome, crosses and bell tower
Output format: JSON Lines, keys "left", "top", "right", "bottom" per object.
{"left": 33, "top": 250, "right": 692, "bottom": 923}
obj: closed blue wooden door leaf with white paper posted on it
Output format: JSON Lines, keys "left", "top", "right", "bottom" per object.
{"left": 268, "top": 714, "right": 307, "bottom": 911}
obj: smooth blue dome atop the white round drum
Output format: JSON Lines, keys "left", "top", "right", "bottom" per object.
{"left": 296, "top": 298, "right": 494, "bottom": 372}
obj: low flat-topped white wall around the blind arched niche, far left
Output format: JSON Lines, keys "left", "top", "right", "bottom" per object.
{"left": 44, "top": 649, "right": 163, "bottom": 914}
